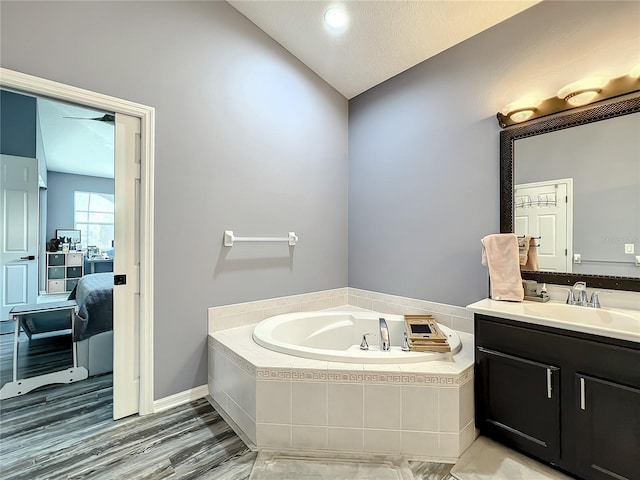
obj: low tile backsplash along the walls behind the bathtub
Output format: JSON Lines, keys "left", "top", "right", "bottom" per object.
{"left": 208, "top": 287, "right": 473, "bottom": 333}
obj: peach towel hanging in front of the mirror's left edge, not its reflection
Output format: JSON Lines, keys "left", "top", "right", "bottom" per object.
{"left": 481, "top": 233, "right": 524, "bottom": 302}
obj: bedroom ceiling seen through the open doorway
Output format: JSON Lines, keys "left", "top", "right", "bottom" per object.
{"left": 37, "top": 98, "right": 114, "bottom": 178}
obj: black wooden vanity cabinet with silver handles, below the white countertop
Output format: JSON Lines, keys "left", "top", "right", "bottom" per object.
{"left": 475, "top": 314, "right": 640, "bottom": 480}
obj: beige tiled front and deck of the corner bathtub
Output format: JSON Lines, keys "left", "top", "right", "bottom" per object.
{"left": 208, "top": 325, "right": 475, "bottom": 462}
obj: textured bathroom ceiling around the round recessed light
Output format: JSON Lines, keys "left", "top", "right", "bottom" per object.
{"left": 227, "top": 0, "right": 540, "bottom": 99}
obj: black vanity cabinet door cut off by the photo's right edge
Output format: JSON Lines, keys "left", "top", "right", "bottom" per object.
{"left": 576, "top": 374, "right": 640, "bottom": 480}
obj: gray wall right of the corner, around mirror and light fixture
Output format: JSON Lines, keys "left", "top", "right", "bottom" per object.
{"left": 349, "top": 2, "right": 640, "bottom": 306}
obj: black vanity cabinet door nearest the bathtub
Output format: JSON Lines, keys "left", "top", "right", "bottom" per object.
{"left": 476, "top": 347, "right": 560, "bottom": 462}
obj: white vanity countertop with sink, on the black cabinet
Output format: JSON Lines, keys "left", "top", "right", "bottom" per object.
{"left": 467, "top": 298, "right": 640, "bottom": 343}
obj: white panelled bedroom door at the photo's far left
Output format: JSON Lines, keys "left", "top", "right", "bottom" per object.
{"left": 0, "top": 155, "right": 38, "bottom": 320}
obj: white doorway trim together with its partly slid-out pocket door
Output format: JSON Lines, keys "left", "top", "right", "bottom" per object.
{"left": 0, "top": 69, "right": 154, "bottom": 418}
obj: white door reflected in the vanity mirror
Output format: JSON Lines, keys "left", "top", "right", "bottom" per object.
{"left": 514, "top": 179, "right": 573, "bottom": 272}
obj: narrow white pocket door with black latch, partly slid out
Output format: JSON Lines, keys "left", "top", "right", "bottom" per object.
{"left": 113, "top": 114, "right": 141, "bottom": 419}
